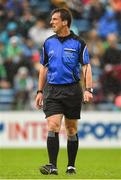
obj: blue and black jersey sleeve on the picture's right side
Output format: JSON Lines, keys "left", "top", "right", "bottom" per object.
{"left": 80, "top": 41, "right": 90, "bottom": 65}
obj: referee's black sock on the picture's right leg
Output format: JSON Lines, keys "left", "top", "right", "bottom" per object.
{"left": 67, "top": 134, "right": 79, "bottom": 167}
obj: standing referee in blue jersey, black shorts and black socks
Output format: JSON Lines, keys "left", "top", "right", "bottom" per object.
{"left": 36, "top": 8, "right": 93, "bottom": 175}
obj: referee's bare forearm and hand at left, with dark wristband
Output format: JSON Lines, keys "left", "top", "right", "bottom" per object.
{"left": 35, "top": 65, "right": 48, "bottom": 109}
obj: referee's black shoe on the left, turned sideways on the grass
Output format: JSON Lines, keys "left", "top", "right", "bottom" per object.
{"left": 40, "top": 164, "right": 58, "bottom": 175}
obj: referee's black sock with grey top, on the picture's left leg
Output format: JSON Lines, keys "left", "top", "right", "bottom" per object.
{"left": 47, "top": 132, "right": 59, "bottom": 166}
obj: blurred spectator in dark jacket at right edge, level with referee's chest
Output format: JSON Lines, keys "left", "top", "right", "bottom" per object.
{"left": 102, "top": 34, "right": 121, "bottom": 95}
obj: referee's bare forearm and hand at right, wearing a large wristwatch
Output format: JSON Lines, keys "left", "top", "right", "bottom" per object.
{"left": 81, "top": 64, "right": 93, "bottom": 102}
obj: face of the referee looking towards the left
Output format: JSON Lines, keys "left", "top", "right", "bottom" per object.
{"left": 50, "top": 12, "right": 65, "bottom": 33}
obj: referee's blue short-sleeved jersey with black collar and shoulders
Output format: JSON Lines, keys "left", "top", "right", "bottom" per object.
{"left": 40, "top": 32, "right": 89, "bottom": 84}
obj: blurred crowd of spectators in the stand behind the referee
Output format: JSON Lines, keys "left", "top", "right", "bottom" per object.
{"left": 0, "top": 0, "right": 121, "bottom": 111}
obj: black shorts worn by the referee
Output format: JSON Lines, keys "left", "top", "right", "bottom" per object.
{"left": 43, "top": 83, "right": 82, "bottom": 119}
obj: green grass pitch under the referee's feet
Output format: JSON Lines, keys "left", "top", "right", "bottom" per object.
{"left": 0, "top": 149, "right": 121, "bottom": 179}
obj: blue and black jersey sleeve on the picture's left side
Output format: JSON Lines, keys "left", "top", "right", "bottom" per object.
{"left": 40, "top": 44, "right": 48, "bottom": 67}
